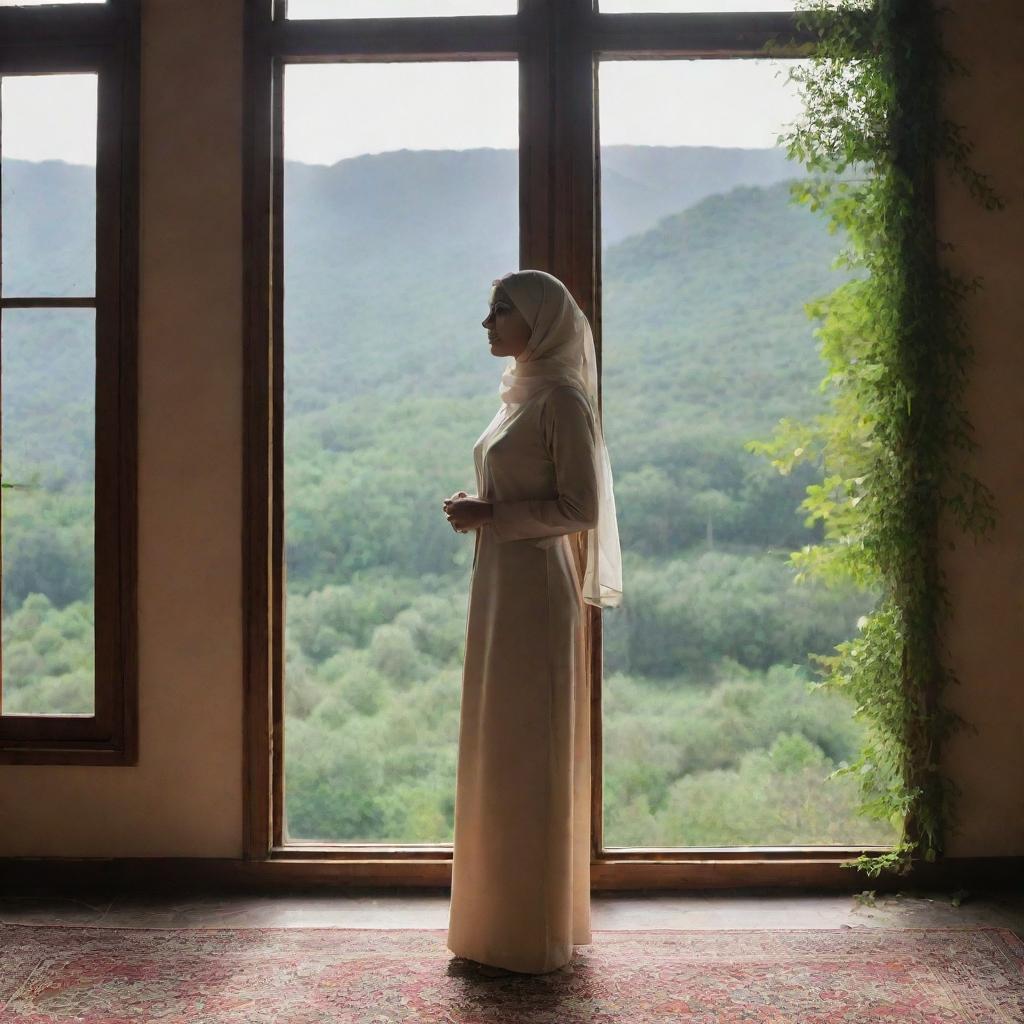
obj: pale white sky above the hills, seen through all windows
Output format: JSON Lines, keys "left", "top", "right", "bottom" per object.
{"left": 0, "top": 0, "right": 800, "bottom": 164}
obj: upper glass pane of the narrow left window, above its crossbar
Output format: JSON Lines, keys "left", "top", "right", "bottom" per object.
{"left": 0, "top": 74, "right": 96, "bottom": 296}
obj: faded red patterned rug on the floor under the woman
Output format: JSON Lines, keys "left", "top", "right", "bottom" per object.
{"left": 0, "top": 925, "right": 1024, "bottom": 1024}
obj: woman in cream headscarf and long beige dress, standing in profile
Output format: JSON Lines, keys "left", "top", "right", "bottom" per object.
{"left": 443, "top": 270, "right": 622, "bottom": 974}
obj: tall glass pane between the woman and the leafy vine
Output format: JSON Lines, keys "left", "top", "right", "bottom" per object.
{"left": 599, "top": 59, "right": 898, "bottom": 848}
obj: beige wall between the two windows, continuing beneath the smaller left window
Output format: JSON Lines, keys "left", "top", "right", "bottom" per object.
{"left": 0, "top": 0, "right": 242, "bottom": 857}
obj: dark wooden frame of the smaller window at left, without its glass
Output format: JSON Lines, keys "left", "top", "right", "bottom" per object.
{"left": 0, "top": 0, "right": 139, "bottom": 765}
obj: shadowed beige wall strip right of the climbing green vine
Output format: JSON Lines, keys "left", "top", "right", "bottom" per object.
{"left": 938, "top": 0, "right": 1024, "bottom": 856}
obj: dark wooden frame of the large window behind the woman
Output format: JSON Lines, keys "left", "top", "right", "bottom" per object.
{"left": 243, "top": 0, "right": 886, "bottom": 888}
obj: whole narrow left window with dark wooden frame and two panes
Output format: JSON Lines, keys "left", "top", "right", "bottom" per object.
{"left": 0, "top": 0, "right": 138, "bottom": 764}
